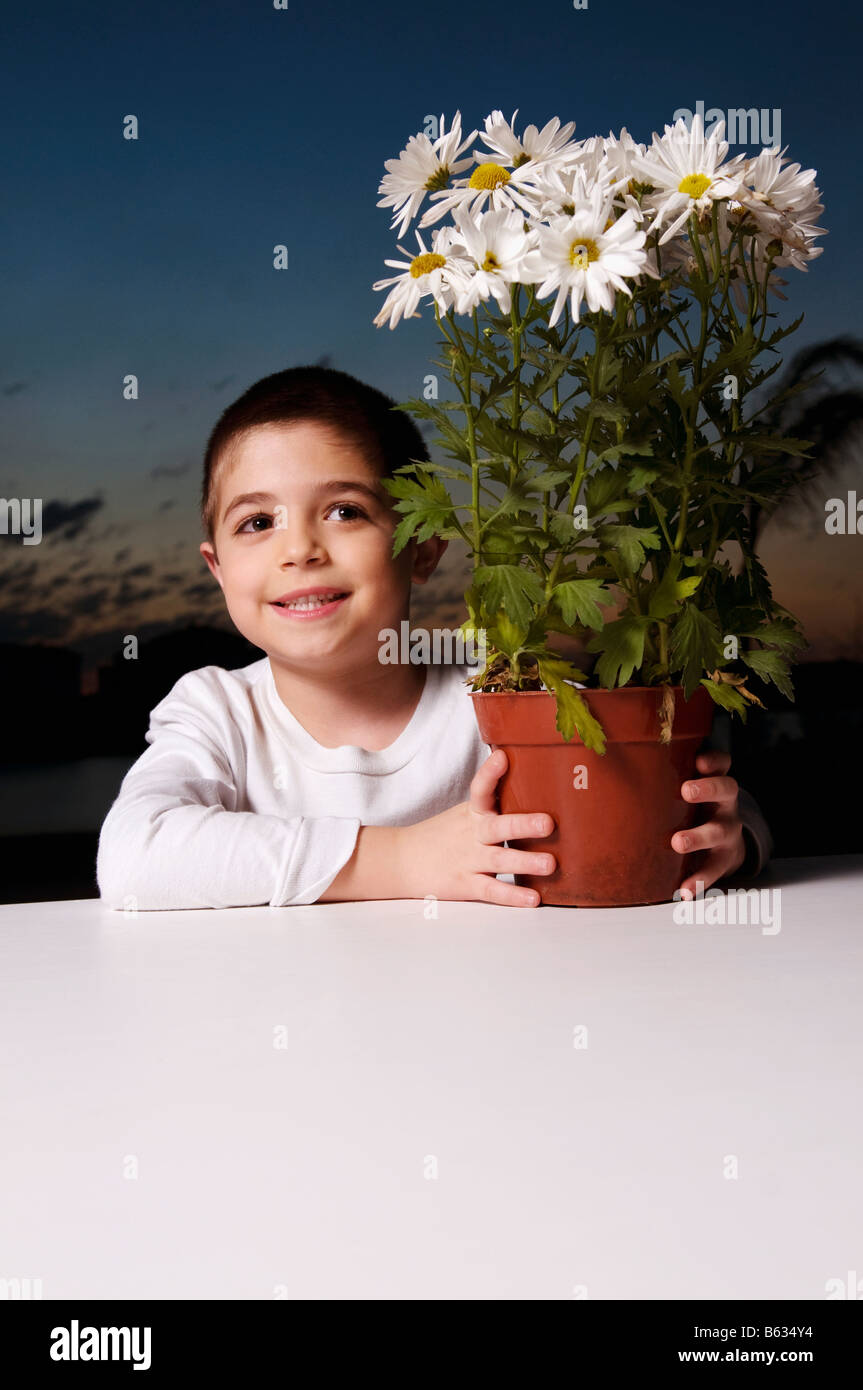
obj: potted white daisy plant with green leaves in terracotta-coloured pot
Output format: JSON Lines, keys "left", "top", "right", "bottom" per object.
{"left": 374, "top": 111, "right": 823, "bottom": 905}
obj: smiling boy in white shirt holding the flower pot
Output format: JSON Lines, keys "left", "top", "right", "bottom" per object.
{"left": 96, "top": 367, "right": 771, "bottom": 910}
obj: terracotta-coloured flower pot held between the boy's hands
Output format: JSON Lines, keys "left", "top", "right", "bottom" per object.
{"left": 471, "top": 685, "right": 716, "bottom": 908}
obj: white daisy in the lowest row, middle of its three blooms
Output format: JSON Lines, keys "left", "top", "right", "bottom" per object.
{"left": 452, "top": 209, "right": 536, "bottom": 314}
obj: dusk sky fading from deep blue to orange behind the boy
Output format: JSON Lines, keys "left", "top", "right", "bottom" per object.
{"left": 0, "top": 0, "right": 863, "bottom": 675}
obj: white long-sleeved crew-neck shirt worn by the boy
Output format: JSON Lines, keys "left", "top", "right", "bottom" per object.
{"left": 96, "top": 656, "right": 773, "bottom": 910}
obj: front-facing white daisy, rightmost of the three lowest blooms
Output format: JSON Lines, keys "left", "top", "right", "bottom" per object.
{"left": 524, "top": 185, "right": 646, "bottom": 328}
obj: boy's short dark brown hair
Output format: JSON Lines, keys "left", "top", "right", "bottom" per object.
{"left": 202, "top": 366, "right": 428, "bottom": 545}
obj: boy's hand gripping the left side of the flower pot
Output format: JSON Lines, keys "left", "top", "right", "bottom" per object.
{"left": 399, "top": 748, "right": 557, "bottom": 908}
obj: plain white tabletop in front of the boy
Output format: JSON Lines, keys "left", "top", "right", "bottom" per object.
{"left": 0, "top": 855, "right": 863, "bottom": 1300}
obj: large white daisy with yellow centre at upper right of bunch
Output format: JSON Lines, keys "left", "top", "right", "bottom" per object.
{"left": 634, "top": 111, "right": 743, "bottom": 246}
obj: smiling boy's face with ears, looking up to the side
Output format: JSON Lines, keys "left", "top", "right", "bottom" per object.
{"left": 200, "top": 421, "right": 447, "bottom": 669}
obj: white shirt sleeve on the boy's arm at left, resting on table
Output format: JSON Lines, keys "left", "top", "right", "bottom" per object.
{"left": 96, "top": 673, "right": 361, "bottom": 910}
